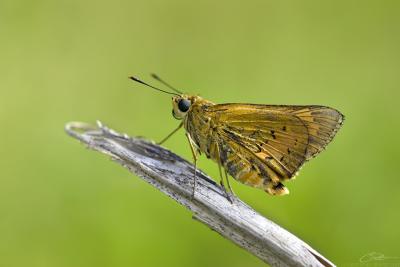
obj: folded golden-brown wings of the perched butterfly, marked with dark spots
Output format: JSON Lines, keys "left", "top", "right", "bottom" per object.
{"left": 207, "top": 104, "right": 344, "bottom": 194}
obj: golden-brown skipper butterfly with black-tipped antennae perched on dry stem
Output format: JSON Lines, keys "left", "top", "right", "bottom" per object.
{"left": 130, "top": 74, "right": 344, "bottom": 199}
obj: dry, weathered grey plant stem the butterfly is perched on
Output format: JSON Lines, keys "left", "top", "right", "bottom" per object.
{"left": 65, "top": 122, "right": 335, "bottom": 266}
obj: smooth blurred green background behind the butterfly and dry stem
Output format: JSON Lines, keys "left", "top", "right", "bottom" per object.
{"left": 0, "top": 0, "right": 400, "bottom": 267}
